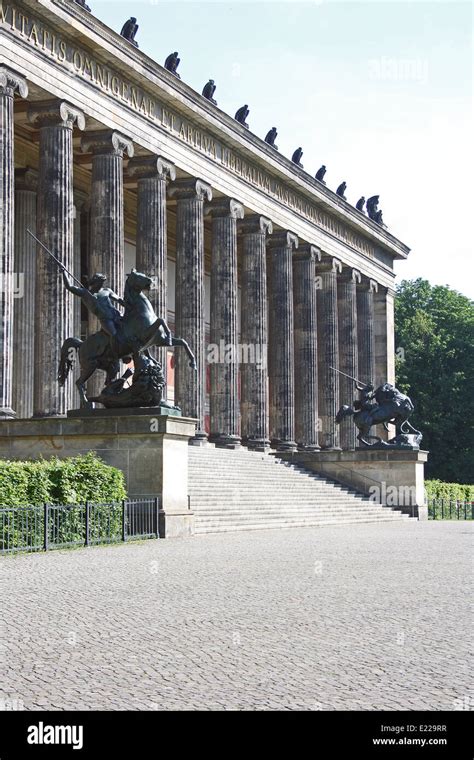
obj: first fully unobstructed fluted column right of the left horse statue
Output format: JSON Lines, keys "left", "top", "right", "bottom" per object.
{"left": 204, "top": 198, "right": 244, "bottom": 449}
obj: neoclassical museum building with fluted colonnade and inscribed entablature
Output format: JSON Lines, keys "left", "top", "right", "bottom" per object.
{"left": 0, "top": 0, "right": 409, "bottom": 452}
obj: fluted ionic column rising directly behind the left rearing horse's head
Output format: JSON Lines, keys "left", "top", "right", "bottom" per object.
{"left": 127, "top": 156, "right": 176, "bottom": 397}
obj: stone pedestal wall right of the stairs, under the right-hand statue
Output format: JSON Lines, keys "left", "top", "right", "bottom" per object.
{"left": 283, "top": 448, "right": 428, "bottom": 520}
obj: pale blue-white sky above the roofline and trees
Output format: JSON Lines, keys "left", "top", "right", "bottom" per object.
{"left": 88, "top": 0, "right": 474, "bottom": 297}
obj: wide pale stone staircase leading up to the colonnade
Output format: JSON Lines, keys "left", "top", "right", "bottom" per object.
{"left": 189, "top": 445, "right": 409, "bottom": 533}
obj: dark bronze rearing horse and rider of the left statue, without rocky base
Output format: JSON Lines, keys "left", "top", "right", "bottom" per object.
{"left": 58, "top": 269, "right": 196, "bottom": 407}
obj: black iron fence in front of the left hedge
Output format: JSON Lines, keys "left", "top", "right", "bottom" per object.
{"left": 0, "top": 497, "right": 160, "bottom": 554}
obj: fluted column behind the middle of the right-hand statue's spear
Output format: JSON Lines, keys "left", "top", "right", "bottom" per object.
{"left": 337, "top": 268, "right": 360, "bottom": 450}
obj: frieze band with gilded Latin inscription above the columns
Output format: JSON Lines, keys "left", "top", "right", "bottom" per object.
{"left": 0, "top": 2, "right": 375, "bottom": 257}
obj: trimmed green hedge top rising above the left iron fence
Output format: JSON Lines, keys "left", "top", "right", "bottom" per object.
{"left": 0, "top": 452, "right": 127, "bottom": 506}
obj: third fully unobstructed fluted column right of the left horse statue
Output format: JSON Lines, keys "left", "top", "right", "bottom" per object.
{"left": 267, "top": 232, "right": 298, "bottom": 451}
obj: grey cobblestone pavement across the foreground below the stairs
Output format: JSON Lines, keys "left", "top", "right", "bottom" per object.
{"left": 0, "top": 521, "right": 474, "bottom": 710}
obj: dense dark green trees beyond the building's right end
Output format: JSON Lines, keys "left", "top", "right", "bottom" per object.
{"left": 395, "top": 278, "right": 474, "bottom": 483}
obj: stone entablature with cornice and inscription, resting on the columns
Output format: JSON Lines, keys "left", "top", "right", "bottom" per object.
{"left": 0, "top": 0, "right": 409, "bottom": 286}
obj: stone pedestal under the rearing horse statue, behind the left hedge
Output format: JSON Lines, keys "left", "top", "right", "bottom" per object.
{"left": 0, "top": 409, "right": 196, "bottom": 538}
